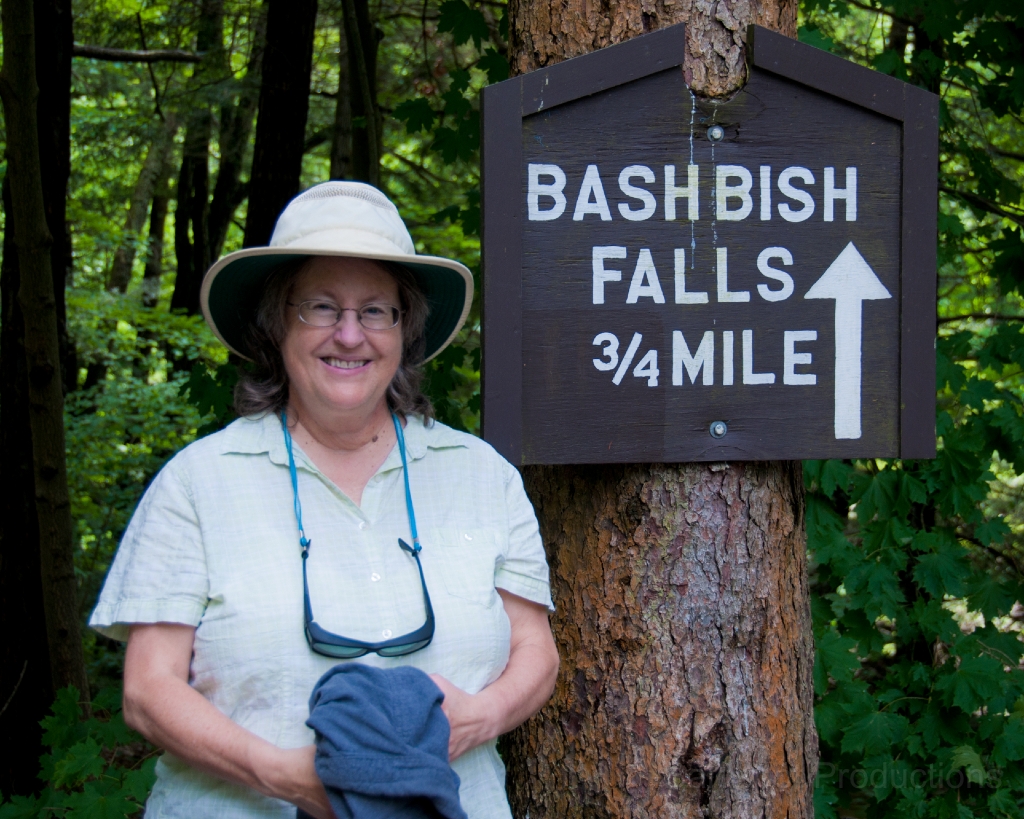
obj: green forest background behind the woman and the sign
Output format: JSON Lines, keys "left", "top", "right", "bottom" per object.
{"left": 0, "top": 0, "right": 1024, "bottom": 819}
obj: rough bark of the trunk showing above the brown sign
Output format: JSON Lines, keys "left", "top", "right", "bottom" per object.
{"left": 509, "top": 0, "right": 798, "bottom": 97}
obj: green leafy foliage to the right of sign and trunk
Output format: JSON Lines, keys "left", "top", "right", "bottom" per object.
{"left": 801, "top": 0, "right": 1024, "bottom": 819}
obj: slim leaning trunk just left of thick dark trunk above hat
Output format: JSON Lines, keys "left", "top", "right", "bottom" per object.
{"left": 204, "top": 4, "right": 267, "bottom": 259}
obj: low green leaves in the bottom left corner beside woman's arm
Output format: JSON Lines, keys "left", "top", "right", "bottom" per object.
{"left": 0, "top": 687, "right": 157, "bottom": 819}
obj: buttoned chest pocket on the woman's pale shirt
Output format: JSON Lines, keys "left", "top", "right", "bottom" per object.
{"left": 423, "top": 527, "right": 501, "bottom": 607}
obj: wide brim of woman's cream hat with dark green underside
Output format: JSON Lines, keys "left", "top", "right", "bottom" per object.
{"left": 200, "top": 248, "right": 473, "bottom": 361}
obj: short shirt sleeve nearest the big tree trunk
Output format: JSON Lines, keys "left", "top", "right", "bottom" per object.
{"left": 495, "top": 464, "right": 555, "bottom": 611}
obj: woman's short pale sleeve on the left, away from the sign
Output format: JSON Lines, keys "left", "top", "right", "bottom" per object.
{"left": 89, "top": 461, "right": 210, "bottom": 640}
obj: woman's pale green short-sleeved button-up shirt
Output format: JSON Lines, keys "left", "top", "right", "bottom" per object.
{"left": 90, "top": 415, "right": 551, "bottom": 819}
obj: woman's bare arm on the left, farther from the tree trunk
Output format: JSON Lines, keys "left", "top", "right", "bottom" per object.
{"left": 124, "top": 622, "right": 334, "bottom": 819}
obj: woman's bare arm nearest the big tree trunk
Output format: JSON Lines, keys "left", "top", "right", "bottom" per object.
{"left": 430, "top": 589, "right": 558, "bottom": 760}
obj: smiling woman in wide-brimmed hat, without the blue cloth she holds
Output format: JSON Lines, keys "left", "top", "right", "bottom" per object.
{"left": 91, "top": 182, "right": 558, "bottom": 819}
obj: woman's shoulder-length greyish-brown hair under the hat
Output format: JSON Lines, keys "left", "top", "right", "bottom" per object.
{"left": 234, "top": 259, "right": 434, "bottom": 420}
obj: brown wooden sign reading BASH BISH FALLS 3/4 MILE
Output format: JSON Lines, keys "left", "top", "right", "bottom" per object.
{"left": 482, "top": 26, "right": 938, "bottom": 464}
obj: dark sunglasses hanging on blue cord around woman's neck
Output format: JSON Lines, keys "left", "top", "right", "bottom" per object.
{"left": 281, "top": 412, "right": 434, "bottom": 659}
